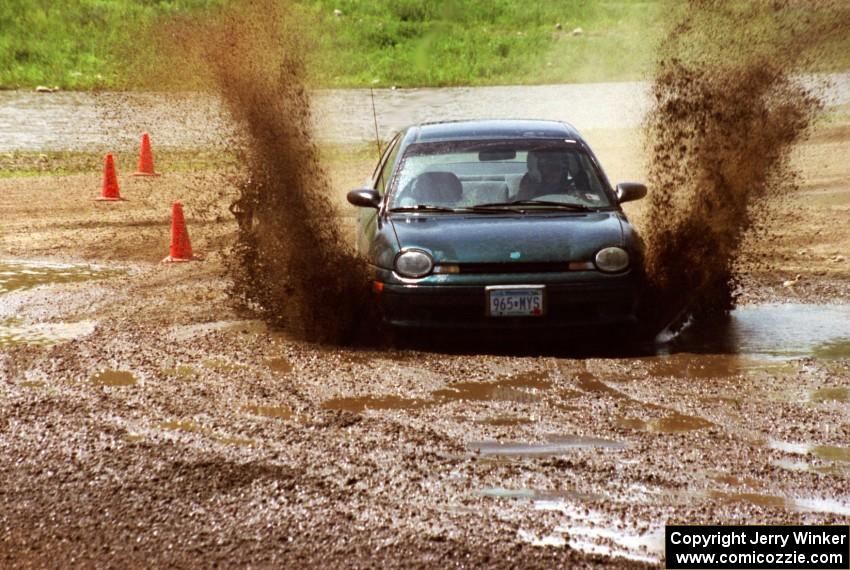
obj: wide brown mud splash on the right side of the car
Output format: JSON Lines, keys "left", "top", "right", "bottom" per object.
{"left": 644, "top": 0, "right": 850, "bottom": 332}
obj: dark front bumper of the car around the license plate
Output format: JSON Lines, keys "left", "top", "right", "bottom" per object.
{"left": 374, "top": 275, "right": 638, "bottom": 332}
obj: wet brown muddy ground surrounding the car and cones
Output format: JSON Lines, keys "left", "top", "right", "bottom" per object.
{"left": 0, "top": 114, "right": 850, "bottom": 568}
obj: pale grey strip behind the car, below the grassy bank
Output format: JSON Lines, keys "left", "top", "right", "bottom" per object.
{"left": 0, "top": 73, "right": 850, "bottom": 152}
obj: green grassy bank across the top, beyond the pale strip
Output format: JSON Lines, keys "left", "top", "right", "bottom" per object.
{"left": 0, "top": 0, "right": 659, "bottom": 89}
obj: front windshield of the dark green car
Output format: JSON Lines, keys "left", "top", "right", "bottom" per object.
{"left": 389, "top": 140, "right": 612, "bottom": 212}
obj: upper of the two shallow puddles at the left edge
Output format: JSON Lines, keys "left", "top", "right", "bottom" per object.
{"left": 0, "top": 259, "right": 126, "bottom": 294}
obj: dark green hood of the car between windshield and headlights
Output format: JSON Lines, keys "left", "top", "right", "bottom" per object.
{"left": 390, "top": 212, "right": 625, "bottom": 263}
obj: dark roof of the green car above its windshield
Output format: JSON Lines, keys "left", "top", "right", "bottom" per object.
{"left": 405, "top": 119, "right": 584, "bottom": 143}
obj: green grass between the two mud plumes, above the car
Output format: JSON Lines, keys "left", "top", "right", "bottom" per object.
{"left": 304, "top": 0, "right": 661, "bottom": 87}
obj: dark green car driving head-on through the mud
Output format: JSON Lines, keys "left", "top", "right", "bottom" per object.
{"left": 348, "top": 120, "right": 646, "bottom": 331}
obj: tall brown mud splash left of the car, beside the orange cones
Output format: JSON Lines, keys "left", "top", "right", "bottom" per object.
{"left": 150, "top": 0, "right": 367, "bottom": 342}
